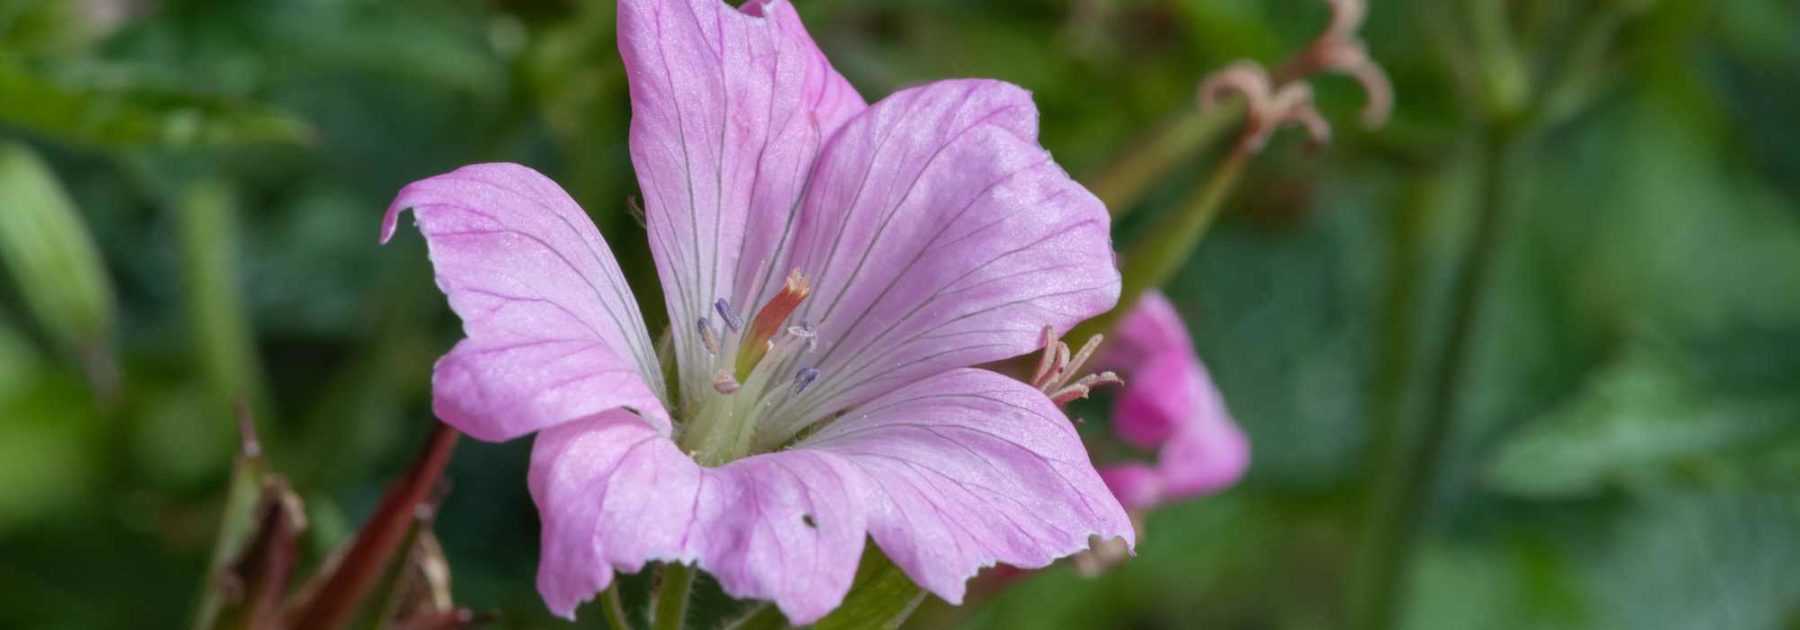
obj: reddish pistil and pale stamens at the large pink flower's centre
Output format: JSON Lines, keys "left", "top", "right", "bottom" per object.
{"left": 677, "top": 272, "right": 819, "bottom": 466}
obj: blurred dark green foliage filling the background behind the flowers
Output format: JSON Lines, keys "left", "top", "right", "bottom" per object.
{"left": 0, "top": 0, "right": 1800, "bottom": 630}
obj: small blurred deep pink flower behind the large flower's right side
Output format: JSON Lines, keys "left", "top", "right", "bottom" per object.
{"left": 1100, "top": 293, "right": 1249, "bottom": 511}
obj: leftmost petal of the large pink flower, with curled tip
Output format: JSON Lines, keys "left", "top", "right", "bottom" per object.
{"left": 382, "top": 164, "right": 670, "bottom": 441}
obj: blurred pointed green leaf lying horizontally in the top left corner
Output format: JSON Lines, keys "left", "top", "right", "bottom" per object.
{"left": 0, "top": 56, "right": 313, "bottom": 148}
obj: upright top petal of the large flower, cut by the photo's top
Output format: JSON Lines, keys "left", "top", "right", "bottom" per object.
{"left": 619, "top": 0, "right": 866, "bottom": 403}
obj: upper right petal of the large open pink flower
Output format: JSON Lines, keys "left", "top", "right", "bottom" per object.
{"left": 770, "top": 79, "right": 1120, "bottom": 443}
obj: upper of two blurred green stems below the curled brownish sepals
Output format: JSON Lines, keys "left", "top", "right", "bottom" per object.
{"left": 1087, "top": 103, "right": 1244, "bottom": 220}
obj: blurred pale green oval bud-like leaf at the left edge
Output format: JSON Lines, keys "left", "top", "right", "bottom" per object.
{"left": 0, "top": 141, "right": 113, "bottom": 369}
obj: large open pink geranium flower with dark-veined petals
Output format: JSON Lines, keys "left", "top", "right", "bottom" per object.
{"left": 382, "top": 0, "right": 1132, "bottom": 623}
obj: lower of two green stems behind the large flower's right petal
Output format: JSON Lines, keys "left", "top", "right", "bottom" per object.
{"left": 1066, "top": 146, "right": 1251, "bottom": 340}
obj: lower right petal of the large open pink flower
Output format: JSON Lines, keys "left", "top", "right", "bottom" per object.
{"left": 790, "top": 369, "right": 1136, "bottom": 603}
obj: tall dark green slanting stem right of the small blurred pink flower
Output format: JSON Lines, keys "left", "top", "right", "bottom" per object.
{"left": 1350, "top": 128, "right": 1514, "bottom": 630}
